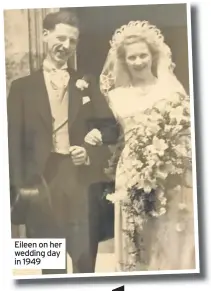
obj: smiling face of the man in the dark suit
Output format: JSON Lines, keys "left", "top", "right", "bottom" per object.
{"left": 43, "top": 23, "right": 79, "bottom": 66}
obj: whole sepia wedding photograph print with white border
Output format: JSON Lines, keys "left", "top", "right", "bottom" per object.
{"left": 4, "top": 3, "right": 199, "bottom": 279}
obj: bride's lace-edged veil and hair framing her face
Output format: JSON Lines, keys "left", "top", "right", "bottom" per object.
{"left": 100, "top": 21, "right": 182, "bottom": 95}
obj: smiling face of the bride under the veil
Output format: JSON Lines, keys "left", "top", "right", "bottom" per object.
{"left": 125, "top": 42, "right": 152, "bottom": 79}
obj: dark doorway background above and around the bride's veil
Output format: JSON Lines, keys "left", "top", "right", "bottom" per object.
{"left": 61, "top": 4, "right": 189, "bottom": 93}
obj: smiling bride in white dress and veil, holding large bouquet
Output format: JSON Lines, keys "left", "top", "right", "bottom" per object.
{"left": 85, "top": 21, "right": 195, "bottom": 272}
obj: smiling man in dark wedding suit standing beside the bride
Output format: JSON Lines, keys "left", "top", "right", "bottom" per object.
{"left": 8, "top": 11, "right": 116, "bottom": 274}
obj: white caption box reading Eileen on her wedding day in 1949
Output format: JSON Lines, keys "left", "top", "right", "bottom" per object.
{"left": 12, "top": 238, "right": 66, "bottom": 269}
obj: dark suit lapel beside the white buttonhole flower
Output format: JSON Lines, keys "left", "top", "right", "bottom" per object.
{"left": 68, "top": 72, "right": 82, "bottom": 127}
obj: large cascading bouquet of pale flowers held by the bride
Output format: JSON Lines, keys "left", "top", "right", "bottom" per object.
{"left": 107, "top": 93, "right": 191, "bottom": 227}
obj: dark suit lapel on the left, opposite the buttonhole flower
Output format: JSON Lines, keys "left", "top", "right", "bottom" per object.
{"left": 31, "top": 70, "right": 52, "bottom": 130}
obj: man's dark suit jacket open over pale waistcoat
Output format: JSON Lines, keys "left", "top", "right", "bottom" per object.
{"left": 8, "top": 69, "right": 117, "bottom": 192}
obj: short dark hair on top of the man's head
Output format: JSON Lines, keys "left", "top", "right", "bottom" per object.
{"left": 43, "top": 9, "right": 79, "bottom": 30}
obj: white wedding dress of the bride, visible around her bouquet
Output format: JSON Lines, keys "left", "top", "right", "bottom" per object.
{"left": 108, "top": 82, "right": 195, "bottom": 272}
